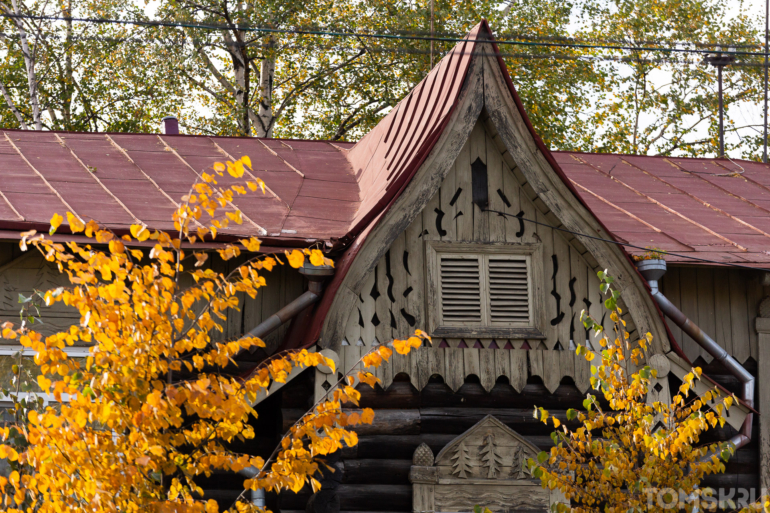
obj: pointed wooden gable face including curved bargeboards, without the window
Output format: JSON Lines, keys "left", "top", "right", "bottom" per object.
{"left": 320, "top": 31, "right": 670, "bottom": 353}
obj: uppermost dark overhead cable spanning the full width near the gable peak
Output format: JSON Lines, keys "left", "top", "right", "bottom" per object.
{"left": 0, "top": 13, "right": 765, "bottom": 57}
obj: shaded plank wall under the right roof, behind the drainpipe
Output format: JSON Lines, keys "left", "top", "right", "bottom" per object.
{"left": 661, "top": 265, "right": 770, "bottom": 363}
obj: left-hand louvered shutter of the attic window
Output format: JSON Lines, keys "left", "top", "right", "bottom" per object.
{"left": 439, "top": 255, "right": 482, "bottom": 325}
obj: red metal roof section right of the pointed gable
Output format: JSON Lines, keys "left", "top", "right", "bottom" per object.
{"left": 553, "top": 152, "right": 770, "bottom": 265}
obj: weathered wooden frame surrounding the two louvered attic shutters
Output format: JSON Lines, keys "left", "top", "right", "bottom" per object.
{"left": 425, "top": 241, "right": 546, "bottom": 340}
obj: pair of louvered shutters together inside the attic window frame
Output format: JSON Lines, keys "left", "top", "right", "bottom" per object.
{"left": 439, "top": 254, "right": 532, "bottom": 327}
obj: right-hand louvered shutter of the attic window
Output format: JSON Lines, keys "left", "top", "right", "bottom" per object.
{"left": 489, "top": 256, "right": 530, "bottom": 324}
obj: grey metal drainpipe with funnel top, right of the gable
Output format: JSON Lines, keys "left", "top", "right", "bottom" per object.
{"left": 636, "top": 260, "right": 754, "bottom": 450}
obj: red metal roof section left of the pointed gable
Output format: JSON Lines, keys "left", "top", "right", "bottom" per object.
{"left": 0, "top": 130, "right": 361, "bottom": 245}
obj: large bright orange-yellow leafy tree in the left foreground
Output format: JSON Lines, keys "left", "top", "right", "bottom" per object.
{"left": 0, "top": 157, "right": 429, "bottom": 513}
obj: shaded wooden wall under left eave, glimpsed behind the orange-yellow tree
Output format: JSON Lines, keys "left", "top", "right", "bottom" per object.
{"left": 0, "top": 242, "right": 305, "bottom": 345}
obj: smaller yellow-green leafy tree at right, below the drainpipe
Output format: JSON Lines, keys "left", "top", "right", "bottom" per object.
{"left": 526, "top": 271, "right": 736, "bottom": 513}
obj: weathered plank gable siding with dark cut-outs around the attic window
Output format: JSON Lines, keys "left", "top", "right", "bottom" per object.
{"left": 343, "top": 120, "right": 635, "bottom": 349}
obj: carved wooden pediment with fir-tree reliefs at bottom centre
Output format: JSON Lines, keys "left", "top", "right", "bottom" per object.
{"left": 409, "top": 415, "right": 563, "bottom": 513}
